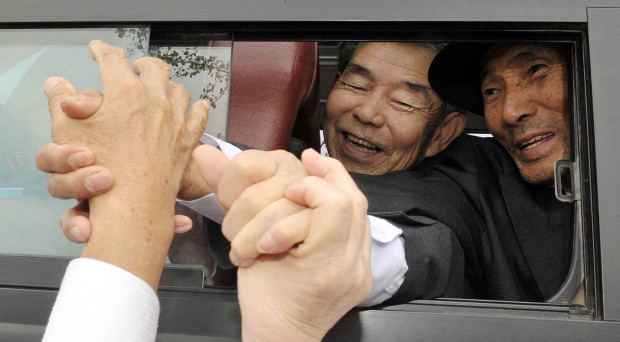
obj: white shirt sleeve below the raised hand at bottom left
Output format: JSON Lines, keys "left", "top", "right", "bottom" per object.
{"left": 43, "top": 258, "right": 159, "bottom": 342}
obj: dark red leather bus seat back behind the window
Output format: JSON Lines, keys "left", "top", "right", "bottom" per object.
{"left": 226, "top": 42, "right": 319, "bottom": 150}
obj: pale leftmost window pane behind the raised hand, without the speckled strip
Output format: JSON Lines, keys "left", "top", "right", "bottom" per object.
{"left": 0, "top": 27, "right": 148, "bottom": 256}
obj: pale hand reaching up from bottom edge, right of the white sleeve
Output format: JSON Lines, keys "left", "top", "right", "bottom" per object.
{"left": 238, "top": 150, "right": 372, "bottom": 341}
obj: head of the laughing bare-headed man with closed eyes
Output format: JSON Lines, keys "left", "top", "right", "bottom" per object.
{"left": 324, "top": 42, "right": 464, "bottom": 175}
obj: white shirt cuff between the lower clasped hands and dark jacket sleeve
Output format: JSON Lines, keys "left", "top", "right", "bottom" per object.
{"left": 359, "top": 215, "right": 409, "bottom": 307}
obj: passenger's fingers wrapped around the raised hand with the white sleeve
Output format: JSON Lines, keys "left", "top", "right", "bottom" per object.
{"left": 35, "top": 63, "right": 212, "bottom": 243}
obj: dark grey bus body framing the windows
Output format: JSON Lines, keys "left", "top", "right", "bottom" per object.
{"left": 0, "top": 0, "right": 620, "bottom": 341}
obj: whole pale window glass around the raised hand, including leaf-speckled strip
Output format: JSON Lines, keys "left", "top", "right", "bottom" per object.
{"left": 0, "top": 26, "right": 230, "bottom": 256}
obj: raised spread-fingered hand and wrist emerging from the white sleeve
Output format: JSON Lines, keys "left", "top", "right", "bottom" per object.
{"left": 44, "top": 41, "right": 208, "bottom": 287}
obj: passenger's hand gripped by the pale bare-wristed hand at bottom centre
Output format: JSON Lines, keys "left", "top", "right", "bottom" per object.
{"left": 194, "top": 146, "right": 307, "bottom": 267}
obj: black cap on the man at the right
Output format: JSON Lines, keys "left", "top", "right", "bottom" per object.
{"left": 428, "top": 42, "right": 494, "bottom": 116}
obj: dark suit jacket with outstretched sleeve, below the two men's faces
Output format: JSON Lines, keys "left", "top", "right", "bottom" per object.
{"left": 353, "top": 135, "right": 573, "bottom": 303}
